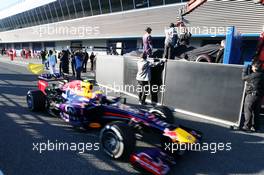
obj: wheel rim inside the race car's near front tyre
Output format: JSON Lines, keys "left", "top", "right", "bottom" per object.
{"left": 102, "top": 131, "right": 120, "bottom": 155}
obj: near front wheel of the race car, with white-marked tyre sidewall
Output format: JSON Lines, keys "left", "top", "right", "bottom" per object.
{"left": 100, "top": 122, "right": 136, "bottom": 160}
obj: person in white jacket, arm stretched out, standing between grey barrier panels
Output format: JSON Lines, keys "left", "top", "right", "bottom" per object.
{"left": 136, "top": 52, "right": 163, "bottom": 105}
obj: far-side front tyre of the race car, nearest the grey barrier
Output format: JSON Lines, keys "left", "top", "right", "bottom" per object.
{"left": 149, "top": 106, "right": 174, "bottom": 124}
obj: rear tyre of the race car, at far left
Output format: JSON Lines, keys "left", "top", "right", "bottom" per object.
{"left": 27, "top": 90, "right": 46, "bottom": 112}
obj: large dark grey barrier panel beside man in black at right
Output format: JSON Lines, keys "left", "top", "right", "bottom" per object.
{"left": 164, "top": 61, "right": 244, "bottom": 124}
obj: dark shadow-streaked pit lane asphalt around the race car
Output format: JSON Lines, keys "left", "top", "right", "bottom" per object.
{"left": 0, "top": 62, "right": 264, "bottom": 175}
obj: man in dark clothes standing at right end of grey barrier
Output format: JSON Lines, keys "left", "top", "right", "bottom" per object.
{"left": 242, "top": 61, "right": 264, "bottom": 132}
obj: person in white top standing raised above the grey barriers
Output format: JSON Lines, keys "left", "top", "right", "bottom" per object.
{"left": 163, "top": 23, "right": 178, "bottom": 59}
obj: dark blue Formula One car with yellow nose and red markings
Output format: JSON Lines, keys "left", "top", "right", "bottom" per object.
{"left": 27, "top": 75, "right": 202, "bottom": 174}
